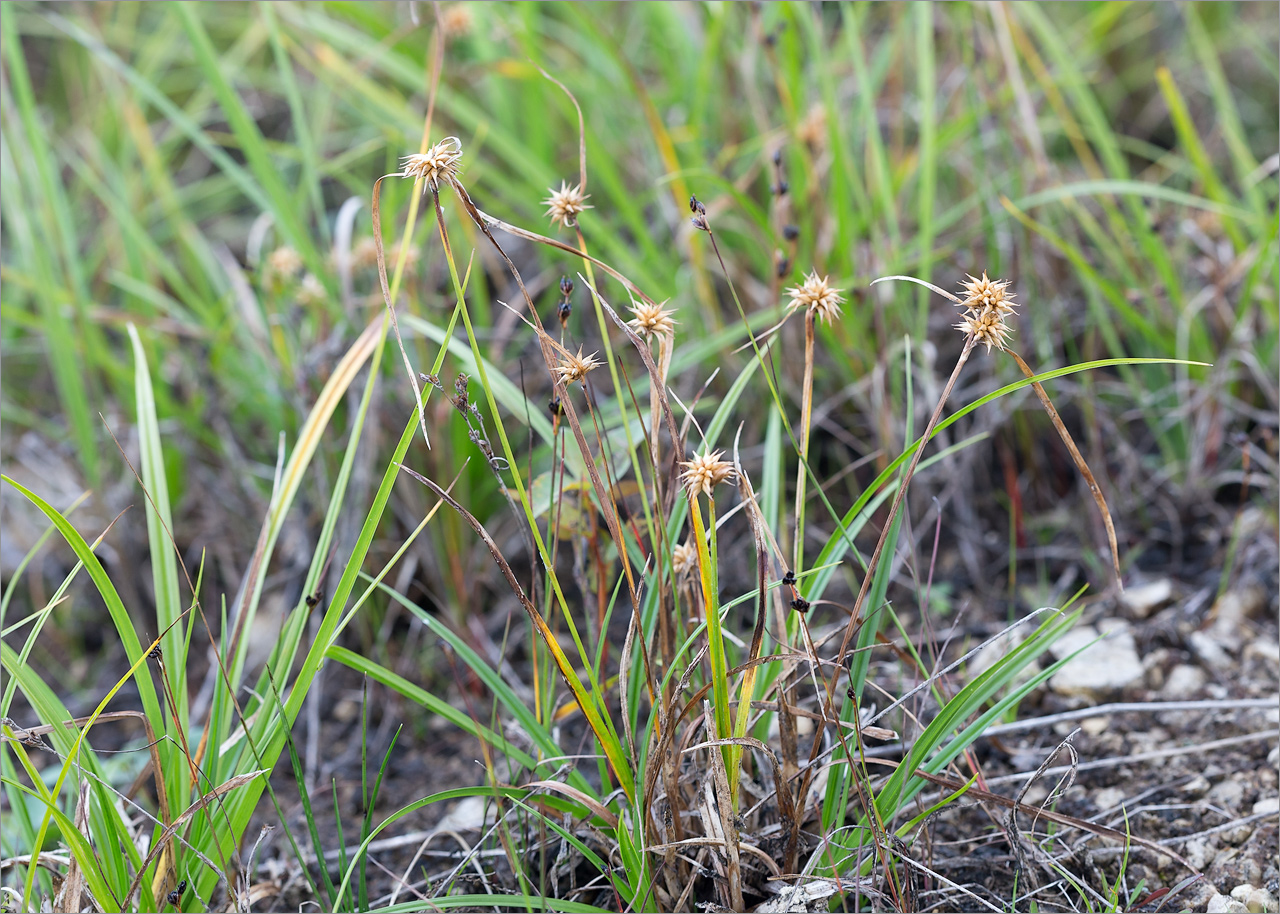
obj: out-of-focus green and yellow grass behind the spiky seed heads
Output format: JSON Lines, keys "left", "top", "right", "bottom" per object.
{"left": 0, "top": 3, "right": 1280, "bottom": 696}
